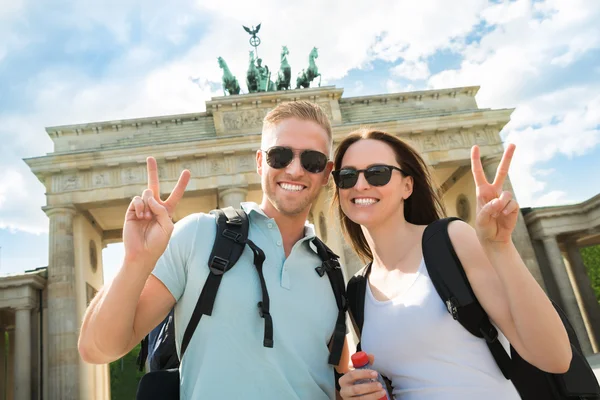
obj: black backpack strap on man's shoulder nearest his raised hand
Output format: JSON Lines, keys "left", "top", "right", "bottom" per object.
{"left": 180, "top": 207, "right": 249, "bottom": 359}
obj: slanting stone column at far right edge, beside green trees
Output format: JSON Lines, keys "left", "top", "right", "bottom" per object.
{"left": 566, "top": 242, "right": 600, "bottom": 348}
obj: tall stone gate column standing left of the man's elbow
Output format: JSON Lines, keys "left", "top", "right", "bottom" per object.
{"left": 44, "top": 207, "right": 79, "bottom": 400}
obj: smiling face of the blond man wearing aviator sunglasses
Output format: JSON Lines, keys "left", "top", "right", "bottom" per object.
{"left": 256, "top": 118, "right": 333, "bottom": 216}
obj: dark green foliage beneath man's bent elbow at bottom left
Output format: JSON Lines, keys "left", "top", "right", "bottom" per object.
{"left": 110, "top": 344, "right": 144, "bottom": 400}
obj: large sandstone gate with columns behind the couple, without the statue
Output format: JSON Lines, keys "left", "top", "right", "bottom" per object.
{"left": 25, "top": 83, "right": 541, "bottom": 400}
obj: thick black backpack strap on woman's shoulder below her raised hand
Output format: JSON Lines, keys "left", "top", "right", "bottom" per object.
{"left": 422, "top": 217, "right": 511, "bottom": 379}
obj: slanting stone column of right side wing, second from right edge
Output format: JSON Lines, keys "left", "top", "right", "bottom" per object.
{"left": 543, "top": 236, "right": 593, "bottom": 355}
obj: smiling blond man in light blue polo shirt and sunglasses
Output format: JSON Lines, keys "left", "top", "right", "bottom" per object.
{"left": 79, "top": 102, "right": 348, "bottom": 400}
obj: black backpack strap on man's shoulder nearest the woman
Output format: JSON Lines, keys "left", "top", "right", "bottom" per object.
{"left": 312, "top": 237, "right": 348, "bottom": 365}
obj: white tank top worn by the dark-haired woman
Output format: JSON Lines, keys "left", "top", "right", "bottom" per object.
{"left": 361, "top": 261, "right": 520, "bottom": 400}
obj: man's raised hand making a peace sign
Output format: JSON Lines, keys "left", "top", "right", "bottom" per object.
{"left": 123, "top": 157, "right": 190, "bottom": 272}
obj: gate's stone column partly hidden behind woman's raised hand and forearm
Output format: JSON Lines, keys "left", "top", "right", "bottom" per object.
{"left": 483, "top": 157, "right": 546, "bottom": 289}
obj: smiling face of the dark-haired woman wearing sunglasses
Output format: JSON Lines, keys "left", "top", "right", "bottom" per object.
{"left": 337, "top": 139, "right": 412, "bottom": 229}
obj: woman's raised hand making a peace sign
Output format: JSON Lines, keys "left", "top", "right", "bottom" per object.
{"left": 471, "top": 144, "right": 519, "bottom": 244}
